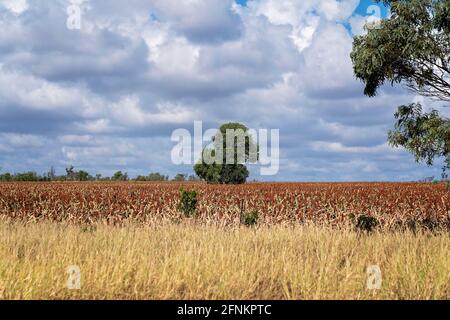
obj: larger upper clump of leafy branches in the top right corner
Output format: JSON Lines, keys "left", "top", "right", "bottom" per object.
{"left": 351, "top": 0, "right": 450, "bottom": 101}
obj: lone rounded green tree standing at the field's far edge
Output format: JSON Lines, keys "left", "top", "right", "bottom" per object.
{"left": 194, "top": 123, "right": 258, "bottom": 184}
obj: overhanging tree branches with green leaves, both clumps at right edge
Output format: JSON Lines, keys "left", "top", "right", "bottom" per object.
{"left": 351, "top": 0, "right": 450, "bottom": 175}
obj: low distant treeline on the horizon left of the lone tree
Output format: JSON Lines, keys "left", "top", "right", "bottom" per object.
{"left": 0, "top": 166, "right": 200, "bottom": 181}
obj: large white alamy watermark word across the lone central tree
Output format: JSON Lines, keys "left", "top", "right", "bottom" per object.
{"left": 171, "top": 121, "right": 280, "bottom": 176}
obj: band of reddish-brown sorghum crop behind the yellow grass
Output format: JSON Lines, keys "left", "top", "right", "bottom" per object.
{"left": 0, "top": 182, "right": 450, "bottom": 229}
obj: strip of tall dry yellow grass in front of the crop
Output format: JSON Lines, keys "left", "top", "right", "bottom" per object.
{"left": 0, "top": 221, "right": 450, "bottom": 299}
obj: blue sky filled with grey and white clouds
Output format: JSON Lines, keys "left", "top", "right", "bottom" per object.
{"left": 0, "top": 0, "right": 448, "bottom": 181}
